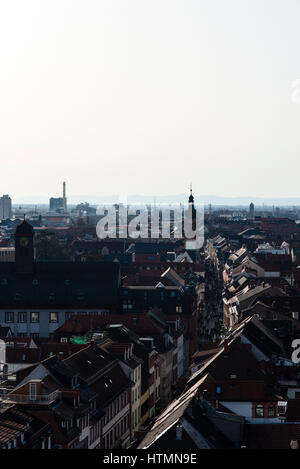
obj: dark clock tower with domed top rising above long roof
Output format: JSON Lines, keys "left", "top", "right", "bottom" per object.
{"left": 15, "top": 219, "right": 34, "bottom": 274}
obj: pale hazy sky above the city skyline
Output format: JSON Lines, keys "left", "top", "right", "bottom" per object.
{"left": 0, "top": 0, "right": 300, "bottom": 200}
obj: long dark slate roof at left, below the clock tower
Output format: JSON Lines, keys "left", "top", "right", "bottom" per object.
{"left": 0, "top": 262, "right": 120, "bottom": 308}
